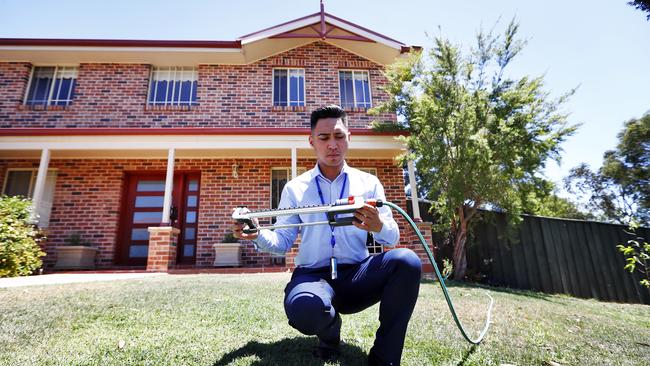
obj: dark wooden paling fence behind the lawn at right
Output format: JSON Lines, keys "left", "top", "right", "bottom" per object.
{"left": 408, "top": 202, "right": 650, "bottom": 304}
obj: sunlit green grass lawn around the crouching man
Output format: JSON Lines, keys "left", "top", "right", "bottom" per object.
{"left": 0, "top": 273, "right": 650, "bottom": 365}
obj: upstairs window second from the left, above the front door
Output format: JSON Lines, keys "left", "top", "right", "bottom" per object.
{"left": 147, "top": 67, "right": 198, "bottom": 105}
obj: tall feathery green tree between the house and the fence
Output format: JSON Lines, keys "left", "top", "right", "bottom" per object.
{"left": 376, "top": 21, "right": 576, "bottom": 279}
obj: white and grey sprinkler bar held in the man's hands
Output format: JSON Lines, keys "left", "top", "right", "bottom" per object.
{"left": 232, "top": 196, "right": 383, "bottom": 234}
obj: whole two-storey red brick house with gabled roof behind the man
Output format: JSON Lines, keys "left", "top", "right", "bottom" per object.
{"left": 0, "top": 8, "right": 430, "bottom": 270}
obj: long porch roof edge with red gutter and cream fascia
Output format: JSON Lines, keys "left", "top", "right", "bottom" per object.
{"left": 0, "top": 128, "right": 405, "bottom": 159}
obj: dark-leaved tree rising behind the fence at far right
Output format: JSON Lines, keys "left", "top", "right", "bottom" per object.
{"left": 565, "top": 113, "right": 650, "bottom": 226}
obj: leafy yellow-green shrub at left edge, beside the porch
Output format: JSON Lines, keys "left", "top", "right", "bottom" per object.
{"left": 0, "top": 196, "right": 45, "bottom": 277}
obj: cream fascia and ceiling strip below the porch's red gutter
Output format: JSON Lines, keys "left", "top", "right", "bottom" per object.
{"left": 0, "top": 135, "right": 404, "bottom": 159}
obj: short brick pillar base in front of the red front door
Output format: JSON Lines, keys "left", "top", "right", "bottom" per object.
{"left": 147, "top": 226, "right": 180, "bottom": 272}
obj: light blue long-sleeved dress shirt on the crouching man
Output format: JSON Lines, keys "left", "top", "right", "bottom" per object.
{"left": 253, "top": 163, "right": 399, "bottom": 268}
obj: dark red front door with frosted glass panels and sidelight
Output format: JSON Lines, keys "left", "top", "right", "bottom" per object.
{"left": 116, "top": 173, "right": 200, "bottom": 266}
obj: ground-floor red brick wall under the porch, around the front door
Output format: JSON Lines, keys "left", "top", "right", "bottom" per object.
{"left": 0, "top": 159, "right": 410, "bottom": 267}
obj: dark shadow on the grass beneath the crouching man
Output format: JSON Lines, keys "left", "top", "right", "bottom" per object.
{"left": 213, "top": 337, "right": 367, "bottom": 366}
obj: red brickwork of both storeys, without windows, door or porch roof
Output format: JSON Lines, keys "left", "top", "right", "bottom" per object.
{"left": 0, "top": 41, "right": 430, "bottom": 270}
